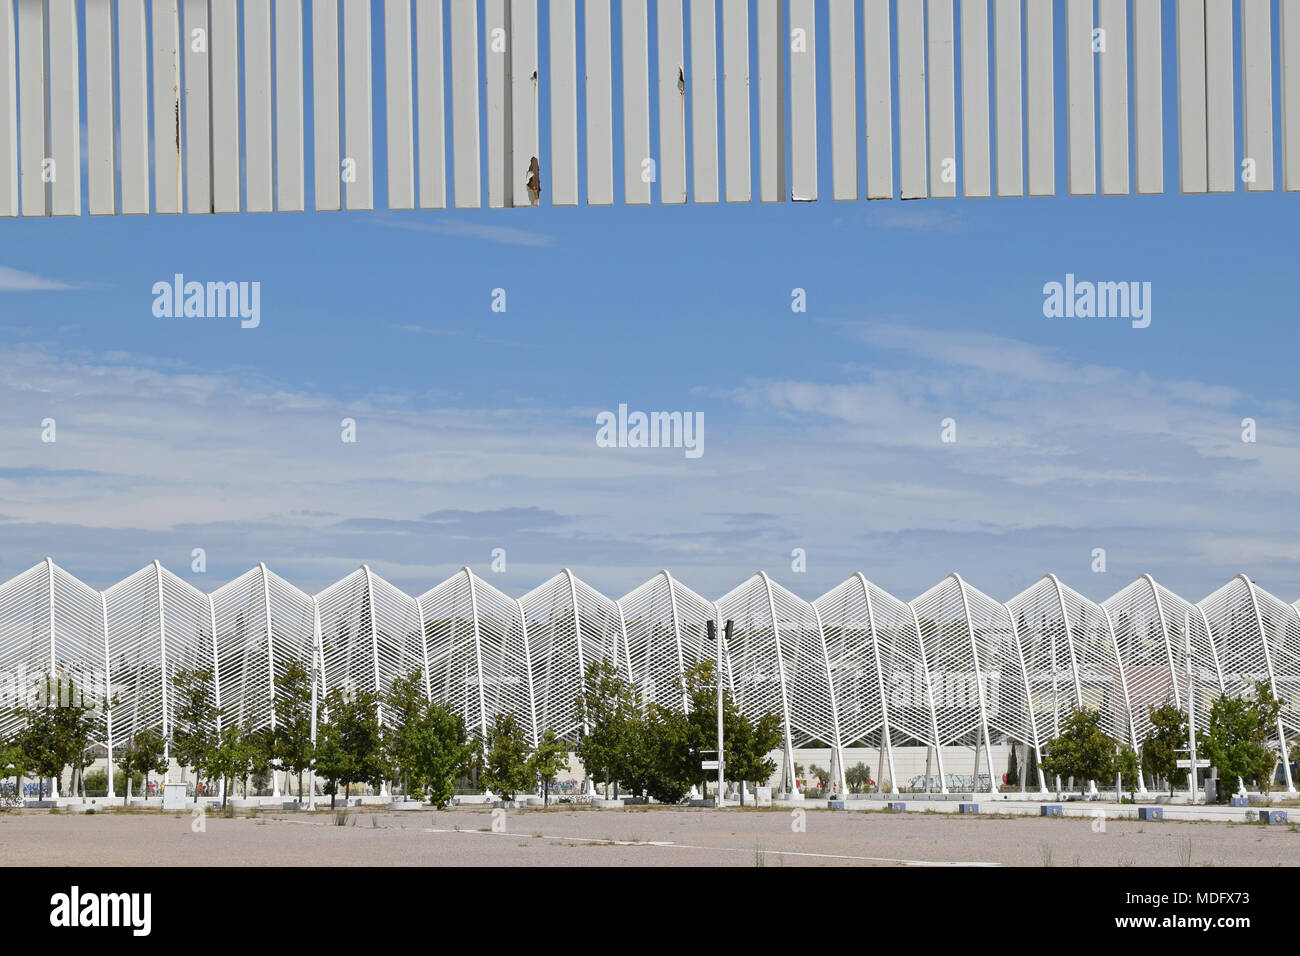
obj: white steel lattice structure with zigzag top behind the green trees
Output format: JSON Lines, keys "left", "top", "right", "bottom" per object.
{"left": 0, "top": 559, "right": 1300, "bottom": 788}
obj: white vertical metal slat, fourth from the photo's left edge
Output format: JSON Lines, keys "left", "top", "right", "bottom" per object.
{"left": 85, "top": 0, "right": 117, "bottom": 216}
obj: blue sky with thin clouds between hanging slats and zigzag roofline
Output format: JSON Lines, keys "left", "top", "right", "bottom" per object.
{"left": 0, "top": 1, "right": 1300, "bottom": 600}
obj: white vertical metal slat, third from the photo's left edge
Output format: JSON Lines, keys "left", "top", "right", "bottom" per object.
{"left": 48, "top": 0, "right": 81, "bottom": 216}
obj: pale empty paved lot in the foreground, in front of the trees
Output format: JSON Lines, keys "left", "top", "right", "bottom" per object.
{"left": 0, "top": 808, "right": 1300, "bottom": 866}
